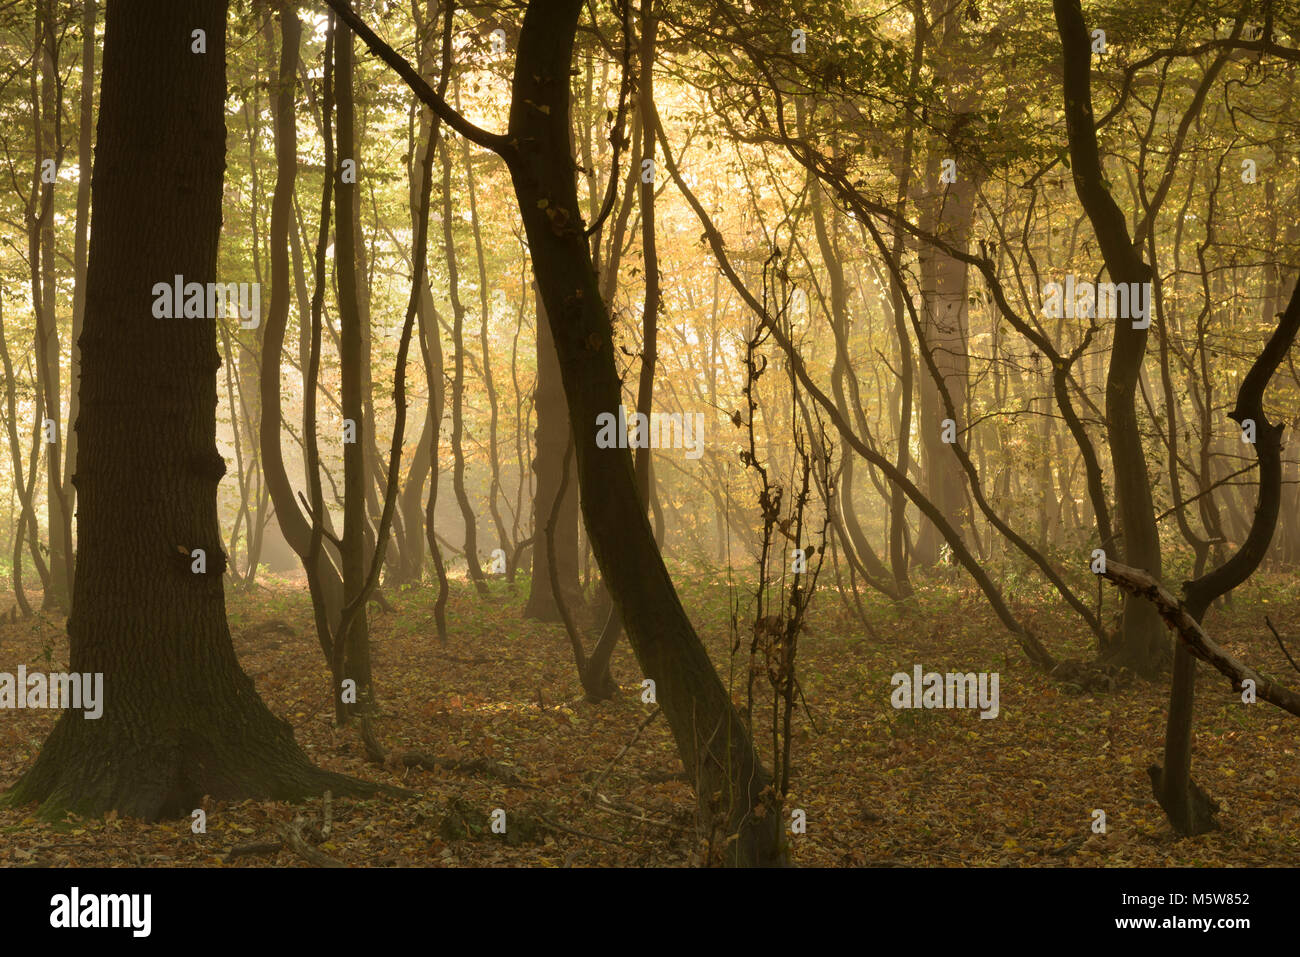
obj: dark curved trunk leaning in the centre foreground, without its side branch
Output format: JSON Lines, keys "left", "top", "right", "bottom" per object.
{"left": 506, "top": 0, "right": 785, "bottom": 865}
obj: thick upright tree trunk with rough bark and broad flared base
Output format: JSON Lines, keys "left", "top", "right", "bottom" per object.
{"left": 8, "top": 0, "right": 373, "bottom": 819}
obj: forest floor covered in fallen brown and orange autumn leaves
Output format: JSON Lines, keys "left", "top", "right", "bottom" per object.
{"left": 0, "top": 567, "right": 1300, "bottom": 867}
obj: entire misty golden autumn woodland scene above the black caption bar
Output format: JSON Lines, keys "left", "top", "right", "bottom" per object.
{"left": 0, "top": 0, "right": 1300, "bottom": 866}
